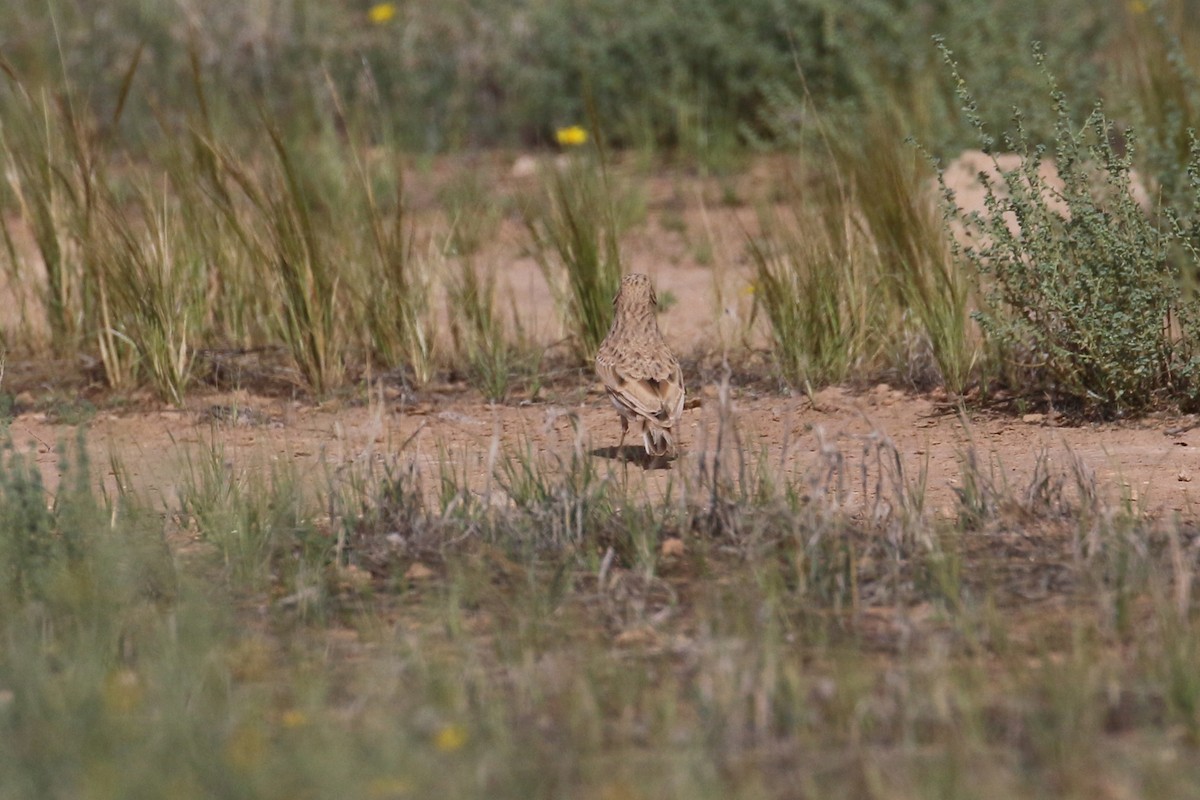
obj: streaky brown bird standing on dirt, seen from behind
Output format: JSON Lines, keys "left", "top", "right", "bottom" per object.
{"left": 596, "top": 275, "right": 684, "bottom": 457}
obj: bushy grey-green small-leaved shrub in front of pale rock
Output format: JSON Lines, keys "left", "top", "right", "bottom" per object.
{"left": 946, "top": 45, "right": 1195, "bottom": 414}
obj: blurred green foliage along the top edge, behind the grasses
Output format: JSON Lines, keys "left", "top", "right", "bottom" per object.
{"left": 0, "top": 0, "right": 1124, "bottom": 152}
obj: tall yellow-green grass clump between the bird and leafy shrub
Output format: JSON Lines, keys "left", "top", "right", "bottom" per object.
{"left": 750, "top": 115, "right": 979, "bottom": 393}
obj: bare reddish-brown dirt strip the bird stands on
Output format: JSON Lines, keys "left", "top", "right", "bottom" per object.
{"left": 11, "top": 386, "right": 1200, "bottom": 518}
